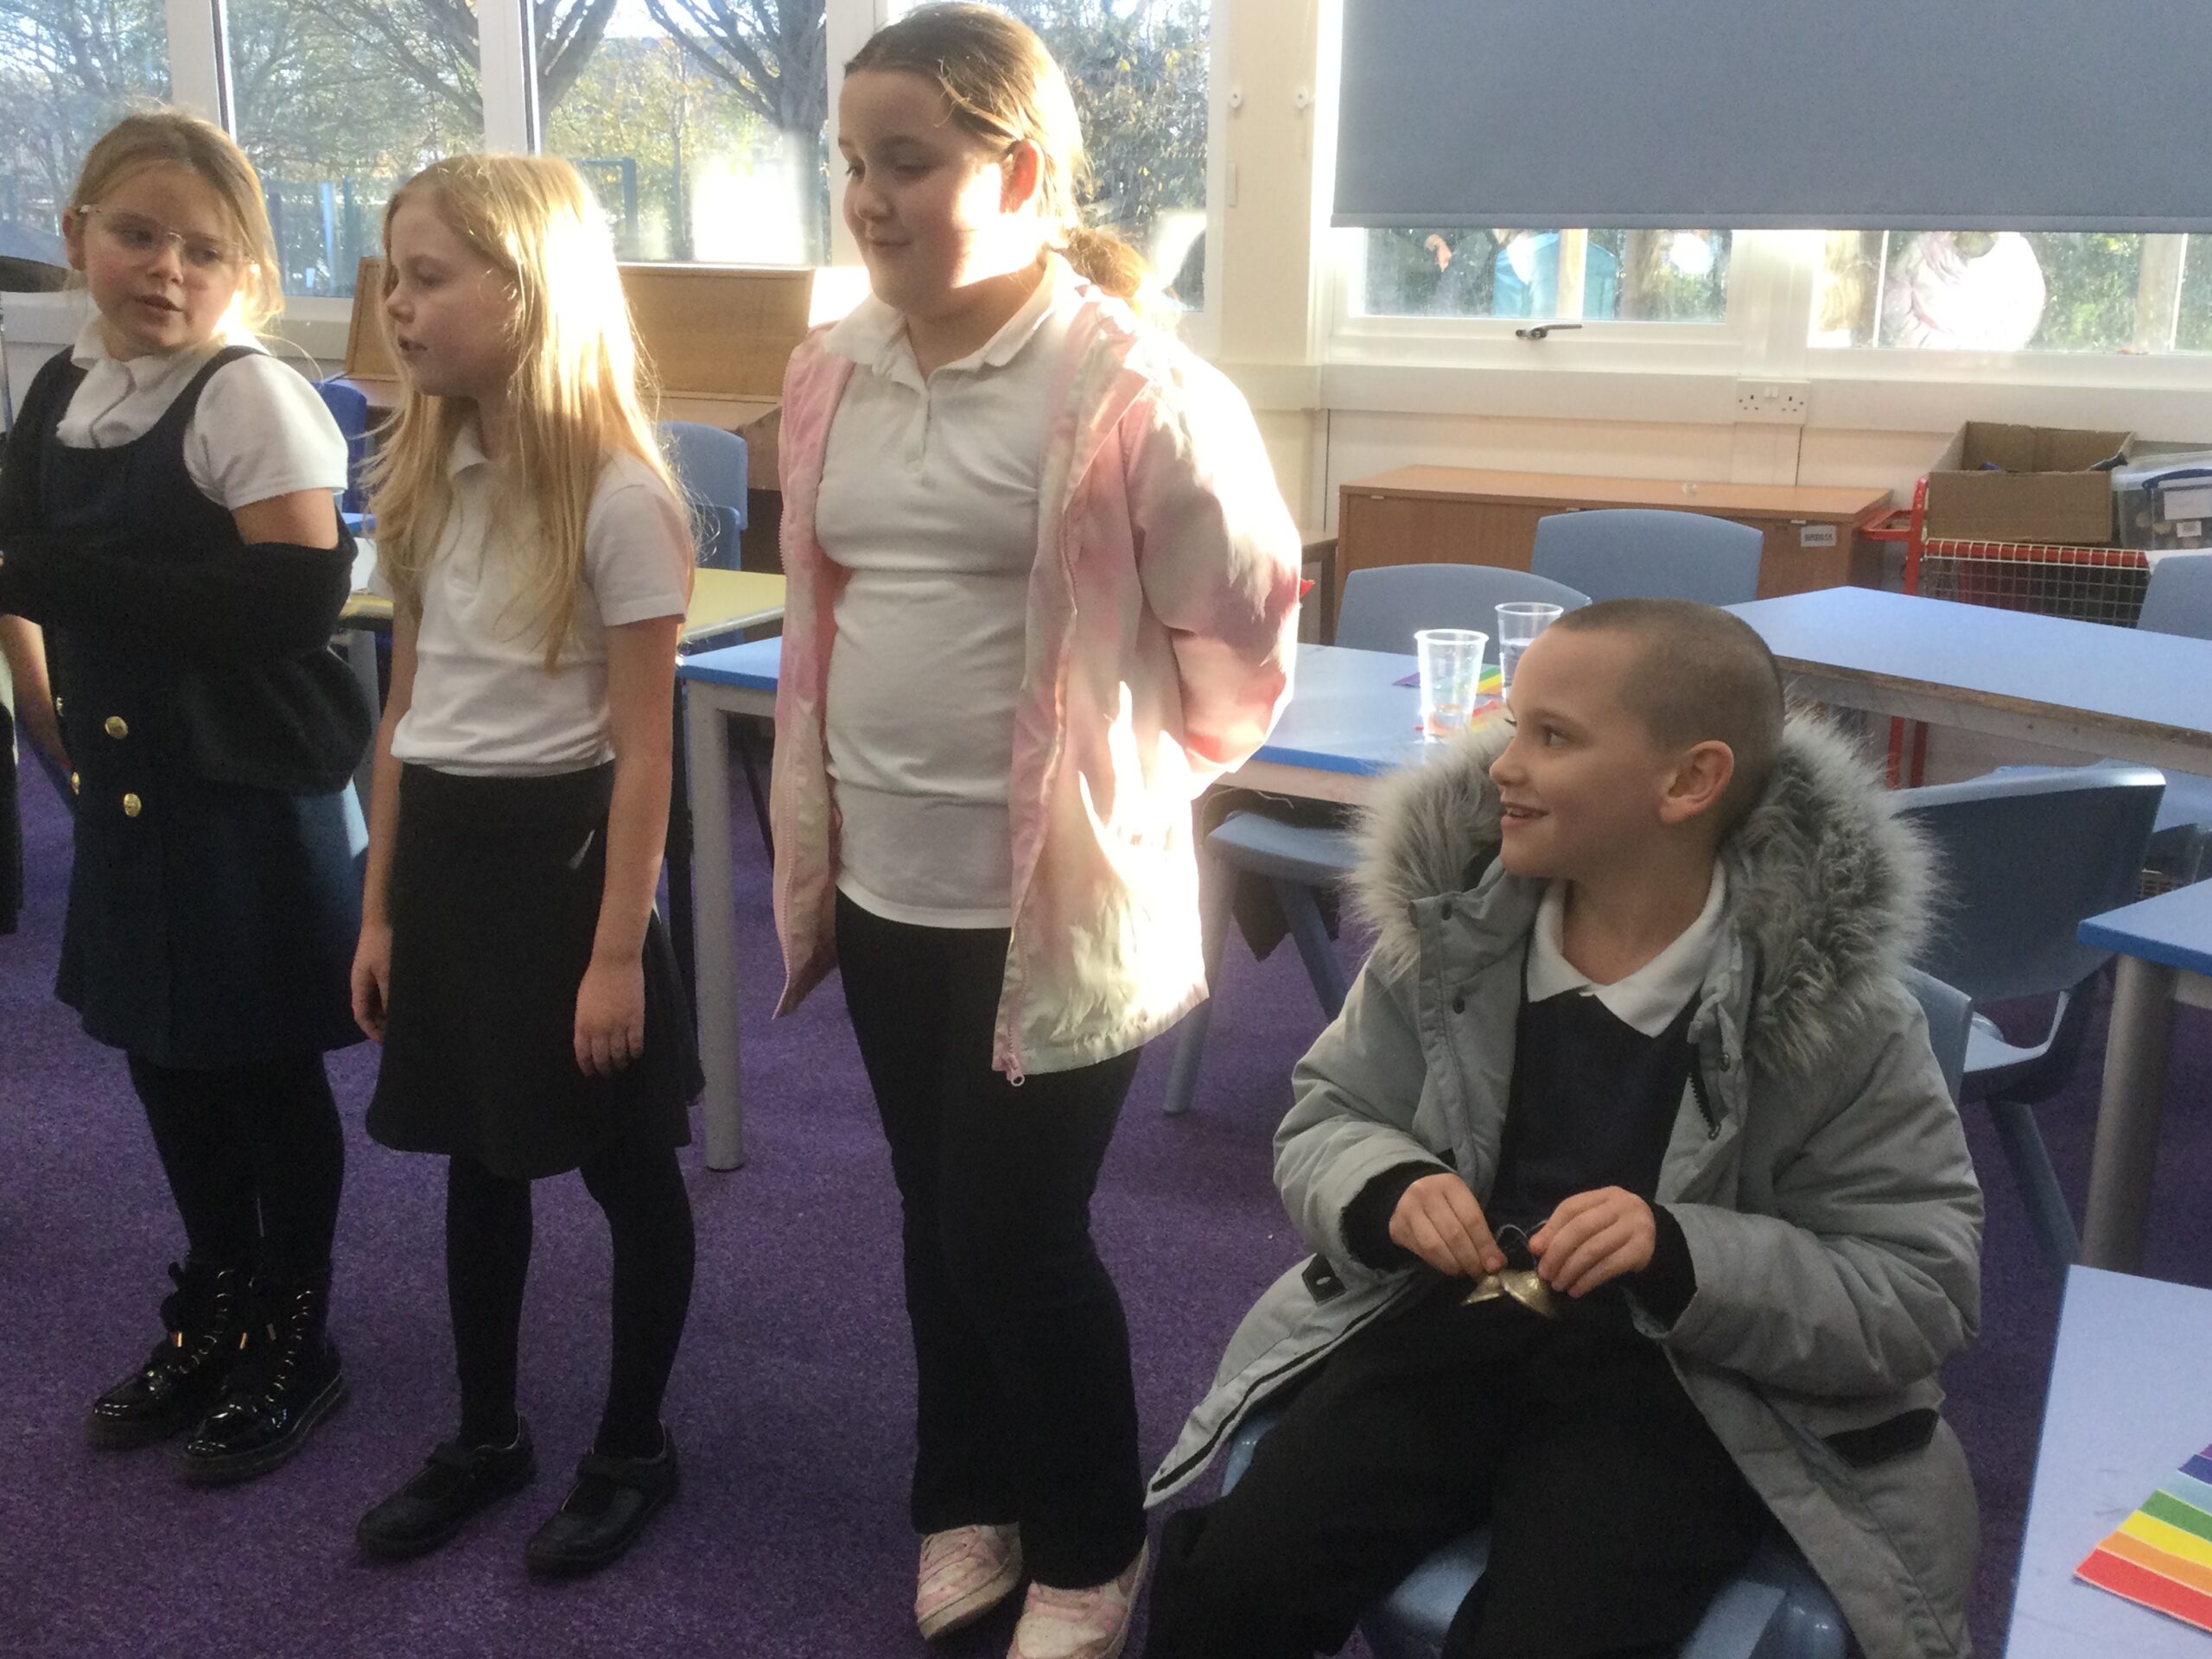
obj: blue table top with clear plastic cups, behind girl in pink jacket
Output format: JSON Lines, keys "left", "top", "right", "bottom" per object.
{"left": 677, "top": 639, "right": 1427, "bottom": 777}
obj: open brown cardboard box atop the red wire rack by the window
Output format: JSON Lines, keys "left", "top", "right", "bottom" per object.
{"left": 1927, "top": 420, "right": 2134, "bottom": 546}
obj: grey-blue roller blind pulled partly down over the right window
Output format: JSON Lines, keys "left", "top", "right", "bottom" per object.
{"left": 1336, "top": 0, "right": 2212, "bottom": 230}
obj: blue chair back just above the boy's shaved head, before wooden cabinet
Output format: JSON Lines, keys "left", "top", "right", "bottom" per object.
{"left": 1529, "top": 506, "right": 1767, "bottom": 604}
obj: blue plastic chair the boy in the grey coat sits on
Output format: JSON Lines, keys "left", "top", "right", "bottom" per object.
{"left": 1194, "top": 969, "right": 1974, "bottom": 1659}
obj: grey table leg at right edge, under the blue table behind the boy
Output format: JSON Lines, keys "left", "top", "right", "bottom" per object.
{"left": 2082, "top": 956, "right": 2174, "bottom": 1274}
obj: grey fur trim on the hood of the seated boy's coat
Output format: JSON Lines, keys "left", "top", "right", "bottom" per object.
{"left": 1351, "top": 712, "right": 1936, "bottom": 1071}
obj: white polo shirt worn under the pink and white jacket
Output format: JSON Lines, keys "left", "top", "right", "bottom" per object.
{"left": 814, "top": 254, "right": 1082, "bottom": 927}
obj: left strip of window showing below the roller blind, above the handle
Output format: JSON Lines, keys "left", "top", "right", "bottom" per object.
{"left": 1351, "top": 230, "right": 1730, "bottom": 323}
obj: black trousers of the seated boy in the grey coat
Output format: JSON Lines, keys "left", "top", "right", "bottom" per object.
{"left": 1146, "top": 1287, "right": 1772, "bottom": 1659}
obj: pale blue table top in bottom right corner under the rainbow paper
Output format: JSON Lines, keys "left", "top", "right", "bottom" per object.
{"left": 2004, "top": 1268, "right": 2212, "bottom": 1659}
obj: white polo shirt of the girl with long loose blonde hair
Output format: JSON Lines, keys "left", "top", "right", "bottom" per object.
{"left": 376, "top": 423, "right": 695, "bottom": 777}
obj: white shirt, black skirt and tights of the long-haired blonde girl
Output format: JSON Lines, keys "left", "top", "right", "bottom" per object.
{"left": 360, "top": 423, "right": 703, "bottom": 1486}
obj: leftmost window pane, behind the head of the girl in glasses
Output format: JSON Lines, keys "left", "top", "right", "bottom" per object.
{"left": 0, "top": 0, "right": 168, "bottom": 265}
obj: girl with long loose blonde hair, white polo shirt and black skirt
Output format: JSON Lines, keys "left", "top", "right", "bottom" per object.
{"left": 354, "top": 155, "right": 699, "bottom": 1575}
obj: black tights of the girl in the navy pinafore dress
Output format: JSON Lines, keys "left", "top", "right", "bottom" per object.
{"left": 130, "top": 1055, "right": 345, "bottom": 1283}
